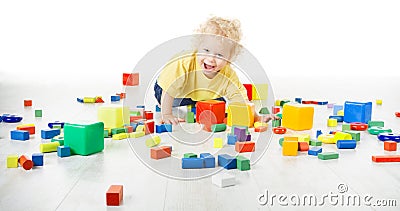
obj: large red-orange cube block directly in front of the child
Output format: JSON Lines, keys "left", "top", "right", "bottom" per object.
{"left": 196, "top": 100, "right": 225, "bottom": 130}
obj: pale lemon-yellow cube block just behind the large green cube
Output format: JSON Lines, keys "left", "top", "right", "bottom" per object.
{"left": 97, "top": 105, "right": 130, "bottom": 128}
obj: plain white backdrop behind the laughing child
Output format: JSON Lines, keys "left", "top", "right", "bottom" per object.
{"left": 0, "top": 0, "right": 400, "bottom": 85}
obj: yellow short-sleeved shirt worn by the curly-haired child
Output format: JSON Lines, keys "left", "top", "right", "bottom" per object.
{"left": 157, "top": 52, "right": 248, "bottom": 102}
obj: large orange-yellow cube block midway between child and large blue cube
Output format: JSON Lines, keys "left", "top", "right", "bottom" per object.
{"left": 282, "top": 104, "right": 314, "bottom": 130}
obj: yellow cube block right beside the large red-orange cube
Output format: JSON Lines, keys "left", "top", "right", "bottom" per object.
{"left": 227, "top": 103, "right": 254, "bottom": 127}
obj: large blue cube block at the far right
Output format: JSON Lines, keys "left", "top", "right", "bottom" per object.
{"left": 344, "top": 101, "right": 372, "bottom": 124}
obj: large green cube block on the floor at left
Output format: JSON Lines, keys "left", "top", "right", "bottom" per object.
{"left": 64, "top": 122, "right": 104, "bottom": 155}
